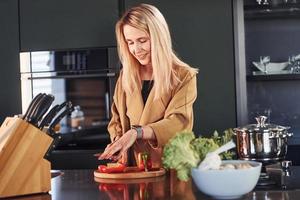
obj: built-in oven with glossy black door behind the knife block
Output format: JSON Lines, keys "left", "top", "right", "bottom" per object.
{"left": 20, "top": 47, "right": 120, "bottom": 168}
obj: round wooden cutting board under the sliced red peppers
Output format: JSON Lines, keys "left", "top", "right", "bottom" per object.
{"left": 94, "top": 167, "right": 166, "bottom": 179}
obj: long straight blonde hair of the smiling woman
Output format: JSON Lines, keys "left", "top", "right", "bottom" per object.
{"left": 116, "top": 4, "right": 196, "bottom": 99}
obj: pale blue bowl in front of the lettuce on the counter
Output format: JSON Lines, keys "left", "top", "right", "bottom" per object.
{"left": 192, "top": 160, "right": 262, "bottom": 199}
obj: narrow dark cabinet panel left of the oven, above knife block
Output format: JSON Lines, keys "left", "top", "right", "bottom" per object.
{"left": 0, "top": 0, "right": 21, "bottom": 123}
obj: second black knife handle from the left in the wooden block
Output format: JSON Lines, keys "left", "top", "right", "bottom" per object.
{"left": 28, "top": 94, "right": 54, "bottom": 127}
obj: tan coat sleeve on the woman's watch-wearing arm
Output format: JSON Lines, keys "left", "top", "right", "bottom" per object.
{"left": 148, "top": 73, "right": 197, "bottom": 148}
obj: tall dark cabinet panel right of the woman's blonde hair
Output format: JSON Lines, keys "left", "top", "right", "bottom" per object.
{"left": 125, "top": 0, "right": 236, "bottom": 135}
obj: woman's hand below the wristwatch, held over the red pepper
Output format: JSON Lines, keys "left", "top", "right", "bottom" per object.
{"left": 99, "top": 129, "right": 137, "bottom": 160}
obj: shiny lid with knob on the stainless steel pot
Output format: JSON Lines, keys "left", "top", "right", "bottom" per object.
{"left": 237, "top": 116, "right": 290, "bottom": 133}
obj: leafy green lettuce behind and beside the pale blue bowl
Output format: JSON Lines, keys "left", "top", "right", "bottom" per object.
{"left": 162, "top": 129, "right": 234, "bottom": 181}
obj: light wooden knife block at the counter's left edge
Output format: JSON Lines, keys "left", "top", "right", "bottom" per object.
{"left": 0, "top": 118, "right": 53, "bottom": 198}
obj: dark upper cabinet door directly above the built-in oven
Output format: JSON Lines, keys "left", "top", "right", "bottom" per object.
{"left": 20, "top": 0, "right": 119, "bottom": 51}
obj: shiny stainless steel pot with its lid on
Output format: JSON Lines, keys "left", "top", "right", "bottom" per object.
{"left": 234, "top": 116, "right": 293, "bottom": 161}
